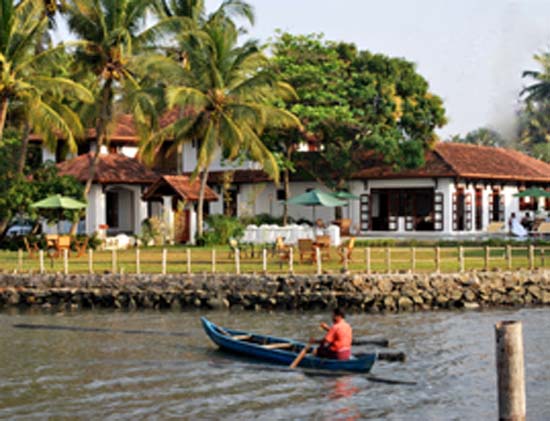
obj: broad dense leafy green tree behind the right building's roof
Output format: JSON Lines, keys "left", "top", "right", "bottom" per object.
{"left": 272, "top": 33, "right": 446, "bottom": 194}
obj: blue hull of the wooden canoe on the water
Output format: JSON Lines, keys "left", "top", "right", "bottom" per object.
{"left": 201, "top": 317, "right": 377, "bottom": 373}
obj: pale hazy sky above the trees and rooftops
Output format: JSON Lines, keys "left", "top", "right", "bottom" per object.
{"left": 207, "top": 0, "right": 550, "bottom": 136}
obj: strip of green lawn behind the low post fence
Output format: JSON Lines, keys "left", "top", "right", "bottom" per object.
{"left": 0, "top": 246, "right": 550, "bottom": 274}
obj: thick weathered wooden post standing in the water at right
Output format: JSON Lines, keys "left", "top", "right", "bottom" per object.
{"left": 495, "top": 321, "right": 526, "bottom": 421}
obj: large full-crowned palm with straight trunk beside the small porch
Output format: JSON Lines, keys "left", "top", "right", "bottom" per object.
{"left": 141, "top": 13, "right": 300, "bottom": 236}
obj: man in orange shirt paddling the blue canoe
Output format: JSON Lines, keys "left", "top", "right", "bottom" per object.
{"left": 315, "top": 308, "right": 353, "bottom": 360}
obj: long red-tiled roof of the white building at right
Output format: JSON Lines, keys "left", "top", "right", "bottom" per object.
{"left": 353, "top": 142, "right": 550, "bottom": 183}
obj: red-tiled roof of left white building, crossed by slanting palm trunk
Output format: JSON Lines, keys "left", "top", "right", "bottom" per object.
{"left": 57, "top": 153, "right": 158, "bottom": 184}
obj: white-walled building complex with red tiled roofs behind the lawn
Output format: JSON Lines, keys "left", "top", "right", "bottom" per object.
{"left": 36, "top": 111, "right": 550, "bottom": 242}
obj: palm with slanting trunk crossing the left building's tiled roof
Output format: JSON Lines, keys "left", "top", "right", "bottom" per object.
{"left": 64, "top": 0, "right": 181, "bottom": 195}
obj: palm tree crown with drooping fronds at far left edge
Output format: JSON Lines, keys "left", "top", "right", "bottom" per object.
{"left": 0, "top": 0, "right": 92, "bottom": 144}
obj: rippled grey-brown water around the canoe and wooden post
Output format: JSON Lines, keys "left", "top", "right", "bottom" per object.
{"left": 0, "top": 309, "right": 550, "bottom": 420}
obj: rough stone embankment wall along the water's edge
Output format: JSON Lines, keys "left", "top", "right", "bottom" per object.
{"left": 0, "top": 271, "right": 550, "bottom": 312}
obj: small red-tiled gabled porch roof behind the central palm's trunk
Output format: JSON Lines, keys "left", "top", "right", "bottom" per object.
{"left": 143, "top": 175, "right": 218, "bottom": 202}
